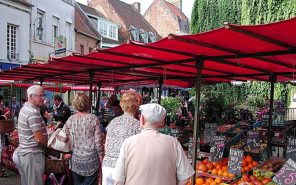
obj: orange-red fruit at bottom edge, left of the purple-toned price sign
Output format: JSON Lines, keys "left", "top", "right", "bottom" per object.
{"left": 232, "top": 174, "right": 271, "bottom": 185}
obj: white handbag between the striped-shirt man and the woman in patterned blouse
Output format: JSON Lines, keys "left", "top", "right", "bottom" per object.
{"left": 47, "top": 128, "right": 72, "bottom": 153}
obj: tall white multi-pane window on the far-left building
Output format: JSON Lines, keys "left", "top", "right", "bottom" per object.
{"left": 7, "top": 24, "right": 18, "bottom": 60}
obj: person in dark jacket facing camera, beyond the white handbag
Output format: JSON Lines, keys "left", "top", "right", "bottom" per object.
{"left": 53, "top": 95, "right": 71, "bottom": 127}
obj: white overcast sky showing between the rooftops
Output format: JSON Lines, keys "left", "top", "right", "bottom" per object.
{"left": 76, "top": 0, "right": 194, "bottom": 20}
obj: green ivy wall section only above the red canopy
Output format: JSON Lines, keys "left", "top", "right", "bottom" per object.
{"left": 191, "top": 0, "right": 296, "bottom": 33}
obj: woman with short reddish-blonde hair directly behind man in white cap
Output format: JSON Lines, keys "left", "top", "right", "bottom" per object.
{"left": 102, "top": 90, "right": 142, "bottom": 185}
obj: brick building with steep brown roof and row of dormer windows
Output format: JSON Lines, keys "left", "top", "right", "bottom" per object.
{"left": 89, "top": 0, "right": 160, "bottom": 43}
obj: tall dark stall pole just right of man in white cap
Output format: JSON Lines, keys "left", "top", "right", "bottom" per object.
{"left": 191, "top": 58, "right": 204, "bottom": 185}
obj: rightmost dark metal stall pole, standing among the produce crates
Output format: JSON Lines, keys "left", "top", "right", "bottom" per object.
{"left": 267, "top": 74, "right": 276, "bottom": 158}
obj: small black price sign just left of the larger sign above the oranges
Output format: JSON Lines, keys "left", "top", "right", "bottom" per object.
{"left": 209, "top": 136, "right": 226, "bottom": 162}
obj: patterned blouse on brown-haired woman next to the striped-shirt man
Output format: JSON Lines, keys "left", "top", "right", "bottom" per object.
{"left": 63, "top": 113, "right": 104, "bottom": 176}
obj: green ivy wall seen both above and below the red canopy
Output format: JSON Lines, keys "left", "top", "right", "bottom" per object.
{"left": 191, "top": 0, "right": 296, "bottom": 106}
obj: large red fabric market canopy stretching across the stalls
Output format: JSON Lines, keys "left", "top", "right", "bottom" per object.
{"left": 0, "top": 18, "right": 296, "bottom": 87}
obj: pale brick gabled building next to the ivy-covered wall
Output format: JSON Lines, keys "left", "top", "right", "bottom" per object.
{"left": 144, "top": 0, "right": 190, "bottom": 37}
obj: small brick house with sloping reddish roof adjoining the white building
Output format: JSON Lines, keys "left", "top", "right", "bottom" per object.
{"left": 75, "top": 3, "right": 101, "bottom": 54}
